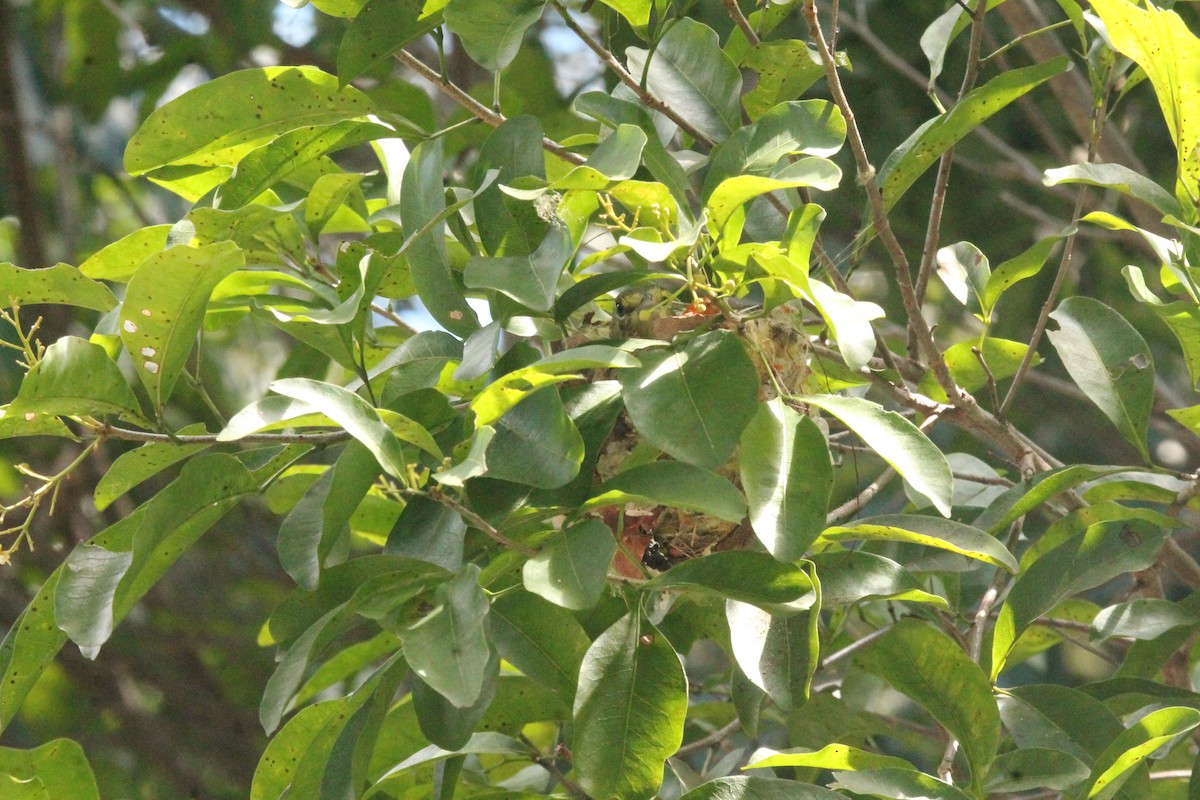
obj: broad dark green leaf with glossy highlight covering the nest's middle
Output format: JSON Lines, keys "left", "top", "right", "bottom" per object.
{"left": 619, "top": 330, "right": 758, "bottom": 469}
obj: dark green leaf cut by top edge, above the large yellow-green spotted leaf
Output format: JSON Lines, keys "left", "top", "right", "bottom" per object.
{"left": 337, "top": 0, "right": 446, "bottom": 84}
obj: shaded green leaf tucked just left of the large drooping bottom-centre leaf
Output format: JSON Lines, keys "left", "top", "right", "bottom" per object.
{"left": 488, "top": 587, "right": 588, "bottom": 703}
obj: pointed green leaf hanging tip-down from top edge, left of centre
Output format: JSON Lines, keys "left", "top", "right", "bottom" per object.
{"left": 445, "top": 0, "right": 546, "bottom": 71}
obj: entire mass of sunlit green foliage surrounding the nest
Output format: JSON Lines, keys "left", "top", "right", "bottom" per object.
{"left": 0, "top": 0, "right": 1200, "bottom": 800}
